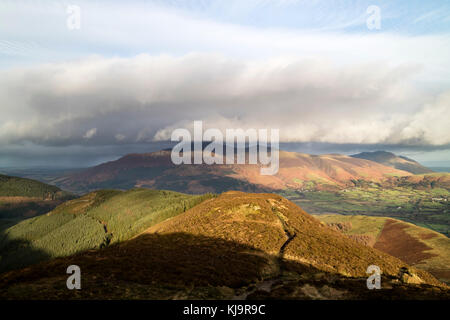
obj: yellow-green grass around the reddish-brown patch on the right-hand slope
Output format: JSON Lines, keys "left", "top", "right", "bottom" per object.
{"left": 316, "top": 214, "right": 450, "bottom": 282}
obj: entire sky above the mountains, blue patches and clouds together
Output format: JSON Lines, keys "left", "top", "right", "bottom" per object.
{"left": 0, "top": 0, "right": 450, "bottom": 166}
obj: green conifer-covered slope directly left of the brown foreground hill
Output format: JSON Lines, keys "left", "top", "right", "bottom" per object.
{"left": 0, "top": 189, "right": 214, "bottom": 271}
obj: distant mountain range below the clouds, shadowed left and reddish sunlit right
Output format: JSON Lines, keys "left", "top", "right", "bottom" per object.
{"left": 54, "top": 151, "right": 411, "bottom": 193}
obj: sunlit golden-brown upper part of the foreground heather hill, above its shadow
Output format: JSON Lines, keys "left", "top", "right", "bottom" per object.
{"left": 147, "top": 191, "right": 437, "bottom": 284}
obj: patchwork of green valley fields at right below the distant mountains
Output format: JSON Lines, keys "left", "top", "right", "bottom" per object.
{"left": 281, "top": 185, "right": 450, "bottom": 236}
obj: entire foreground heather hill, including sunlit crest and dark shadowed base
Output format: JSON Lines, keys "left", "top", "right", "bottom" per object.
{"left": 0, "top": 192, "right": 450, "bottom": 299}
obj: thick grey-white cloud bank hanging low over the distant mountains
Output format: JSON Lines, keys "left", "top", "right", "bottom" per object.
{"left": 0, "top": 53, "right": 450, "bottom": 146}
